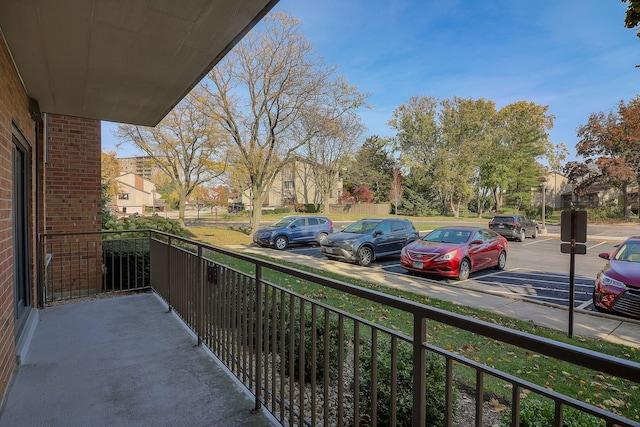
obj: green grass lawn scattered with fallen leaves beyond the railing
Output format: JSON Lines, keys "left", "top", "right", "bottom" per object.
{"left": 189, "top": 222, "right": 640, "bottom": 421}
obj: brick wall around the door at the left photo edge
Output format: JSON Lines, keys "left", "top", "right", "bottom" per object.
{"left": 0, "top": 36, "right": 35, "bottom": 397}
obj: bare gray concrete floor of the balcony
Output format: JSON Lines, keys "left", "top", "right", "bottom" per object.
{"left": 0, "top": 293, "right": 275, "bottom": 427}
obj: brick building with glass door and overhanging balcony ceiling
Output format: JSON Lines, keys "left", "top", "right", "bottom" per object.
{"left": 0, "top": 0, "right": 277, "bottom": 408}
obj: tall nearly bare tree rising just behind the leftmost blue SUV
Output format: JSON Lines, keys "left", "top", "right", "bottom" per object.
{"left": 202, "top": 13, "right": 365, "bottom": 228}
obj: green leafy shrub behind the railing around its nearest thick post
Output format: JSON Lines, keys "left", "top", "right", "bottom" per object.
{"left": 360, "top": 336, "right": 456, "bottom": 427}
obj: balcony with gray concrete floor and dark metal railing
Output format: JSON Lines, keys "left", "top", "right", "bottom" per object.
{"left": 0, "top": 231, "right": 640, "bottom": 426}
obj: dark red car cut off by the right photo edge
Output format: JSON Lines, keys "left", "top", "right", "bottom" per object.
{"left": 593, "top": 236, "right": 640, "bottom": 318}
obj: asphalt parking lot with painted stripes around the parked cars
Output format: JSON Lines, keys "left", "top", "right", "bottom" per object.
{"left": 258, "top": 236, "right": 619, "bottom": 310}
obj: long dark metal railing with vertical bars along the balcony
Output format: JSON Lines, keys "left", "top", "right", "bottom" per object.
{"left": 38, "top": 231, "right": 640, "bottom": 426}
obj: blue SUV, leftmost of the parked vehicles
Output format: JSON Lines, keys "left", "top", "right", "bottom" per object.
{"left": 253, "top": 215, "right": 333, "bottom": 249}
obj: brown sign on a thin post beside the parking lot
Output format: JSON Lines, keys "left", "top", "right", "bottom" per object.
{"left": 560, "top": 210, "right": 587, "bottom": 338}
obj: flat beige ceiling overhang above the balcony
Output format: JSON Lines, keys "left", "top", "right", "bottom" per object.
{"left": 0, "top": 0, "right": 278, "bottom": 126}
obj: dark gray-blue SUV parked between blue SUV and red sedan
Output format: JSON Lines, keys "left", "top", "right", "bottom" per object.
{"left": 319, "top": 219, "right": 418, "bottom": 265}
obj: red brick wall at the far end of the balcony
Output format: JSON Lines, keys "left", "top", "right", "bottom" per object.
{"left": 44, "top": 114, "right": 102, "bottom": 296}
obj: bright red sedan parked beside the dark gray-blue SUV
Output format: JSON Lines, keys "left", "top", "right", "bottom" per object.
{"left": 400, "top": 227, "right": 508, "bottom": 280}
